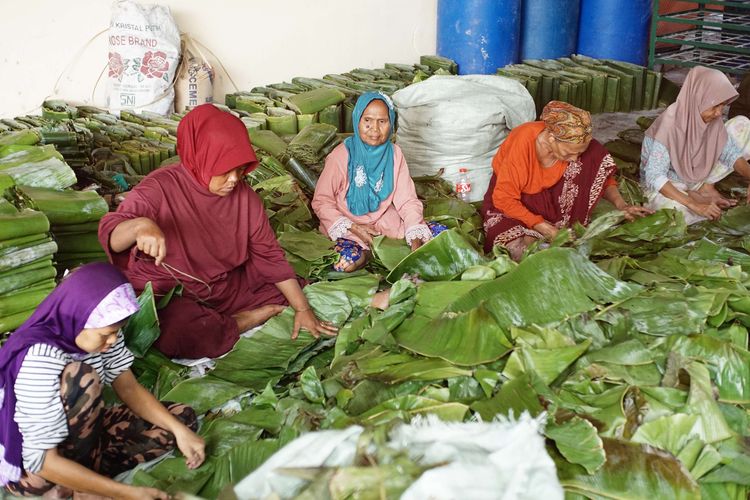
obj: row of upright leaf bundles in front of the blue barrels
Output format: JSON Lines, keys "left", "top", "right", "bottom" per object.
{"left": 497, "top": 55, "right": 662, "bottom": 113}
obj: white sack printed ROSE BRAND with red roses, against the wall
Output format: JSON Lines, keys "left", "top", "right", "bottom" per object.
{"left": 107, "top": 0, "right": 180, "bottom": 115}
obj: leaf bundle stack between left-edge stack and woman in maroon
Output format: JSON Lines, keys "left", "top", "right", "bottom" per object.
{"left": 19, "top": 187, "right": 109, "bottom": 272}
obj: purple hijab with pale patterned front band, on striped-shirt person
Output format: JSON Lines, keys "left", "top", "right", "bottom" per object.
{"left": 0, "top": 262, "right": 138, "bottom": 485}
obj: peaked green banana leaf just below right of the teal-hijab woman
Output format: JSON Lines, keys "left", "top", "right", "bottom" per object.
{"left": 386, "top": 229, "right": 485, "bottom": 283}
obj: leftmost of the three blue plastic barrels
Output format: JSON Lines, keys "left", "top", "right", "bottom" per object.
{"left": 437, "top": 0, "right": 521, "bottom": 75}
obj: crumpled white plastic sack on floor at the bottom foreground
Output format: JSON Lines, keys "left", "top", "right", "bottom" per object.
{"left": 234, "top": 415, "right": 563, "bottom": 500}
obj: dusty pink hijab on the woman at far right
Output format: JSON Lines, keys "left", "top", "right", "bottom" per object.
{"left": 646, "top": 66, "right": 737, "bottom": 184}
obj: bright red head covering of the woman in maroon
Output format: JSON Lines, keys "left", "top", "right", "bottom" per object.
{"left": 177, "top": 104, "right": 258, "bottom": 188}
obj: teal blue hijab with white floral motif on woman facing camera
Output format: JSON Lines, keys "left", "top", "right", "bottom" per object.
{"left": 344, "top": 92, "right": 396, "bottom": 215}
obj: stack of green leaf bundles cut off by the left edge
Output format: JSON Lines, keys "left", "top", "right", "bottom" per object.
{"left": 0, "top": 193, "right": 57, "bottom": 334}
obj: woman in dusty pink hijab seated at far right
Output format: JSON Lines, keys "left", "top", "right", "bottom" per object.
{"left": 641, "top": 66, "right": 750, "bottom": 224}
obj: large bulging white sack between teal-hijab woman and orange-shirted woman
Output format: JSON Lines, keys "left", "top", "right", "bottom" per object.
{"left": 393, "top": 75, "right": 536, "bottom": 202}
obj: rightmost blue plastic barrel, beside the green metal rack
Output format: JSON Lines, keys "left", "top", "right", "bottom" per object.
{"left": 577, "top": 0, "right": 653, "bottom": 65}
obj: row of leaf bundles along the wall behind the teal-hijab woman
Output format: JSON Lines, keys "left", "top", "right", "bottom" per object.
{"left": 225, "top": 56, "right": 457, "bottom": 136}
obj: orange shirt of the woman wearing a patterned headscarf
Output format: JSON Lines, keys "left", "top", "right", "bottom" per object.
{"left": 492, "top": 122, "right": 617, "bottom": 228}
